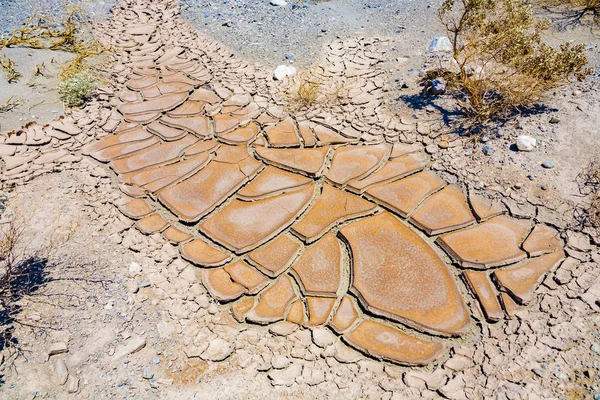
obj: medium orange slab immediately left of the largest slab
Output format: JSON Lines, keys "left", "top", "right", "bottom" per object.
{"left": 291, "top": 233, "right": 342, "bottom": 297}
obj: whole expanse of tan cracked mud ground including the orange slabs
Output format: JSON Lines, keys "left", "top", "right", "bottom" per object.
{"left": 0, "top": 0, "right": 600, "bottom": 399}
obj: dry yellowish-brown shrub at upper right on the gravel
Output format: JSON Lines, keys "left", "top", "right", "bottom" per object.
{"left": 439, "top": 0, "right": 591, "bottom": 123}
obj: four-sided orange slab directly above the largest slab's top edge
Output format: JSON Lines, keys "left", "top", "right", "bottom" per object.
{"left": 366, "top": 171, "right": 446, "bottom": 217}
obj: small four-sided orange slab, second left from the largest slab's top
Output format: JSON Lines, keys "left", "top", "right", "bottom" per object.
{"left": 248, "top": 235, "right": 302, "bottom": 278}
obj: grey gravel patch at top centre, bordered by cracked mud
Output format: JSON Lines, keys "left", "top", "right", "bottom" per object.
{"left": 180, "top": 0, "right": 441, "bottom": 68}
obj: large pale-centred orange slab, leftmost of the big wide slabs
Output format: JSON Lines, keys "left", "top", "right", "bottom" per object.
{"left": 158, "top": 161, "right": 258, "bottom": 222}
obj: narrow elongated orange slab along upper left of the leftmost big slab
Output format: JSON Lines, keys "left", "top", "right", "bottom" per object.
{"left": 120, "top": 153, "right": 210, "bottom": 192}
